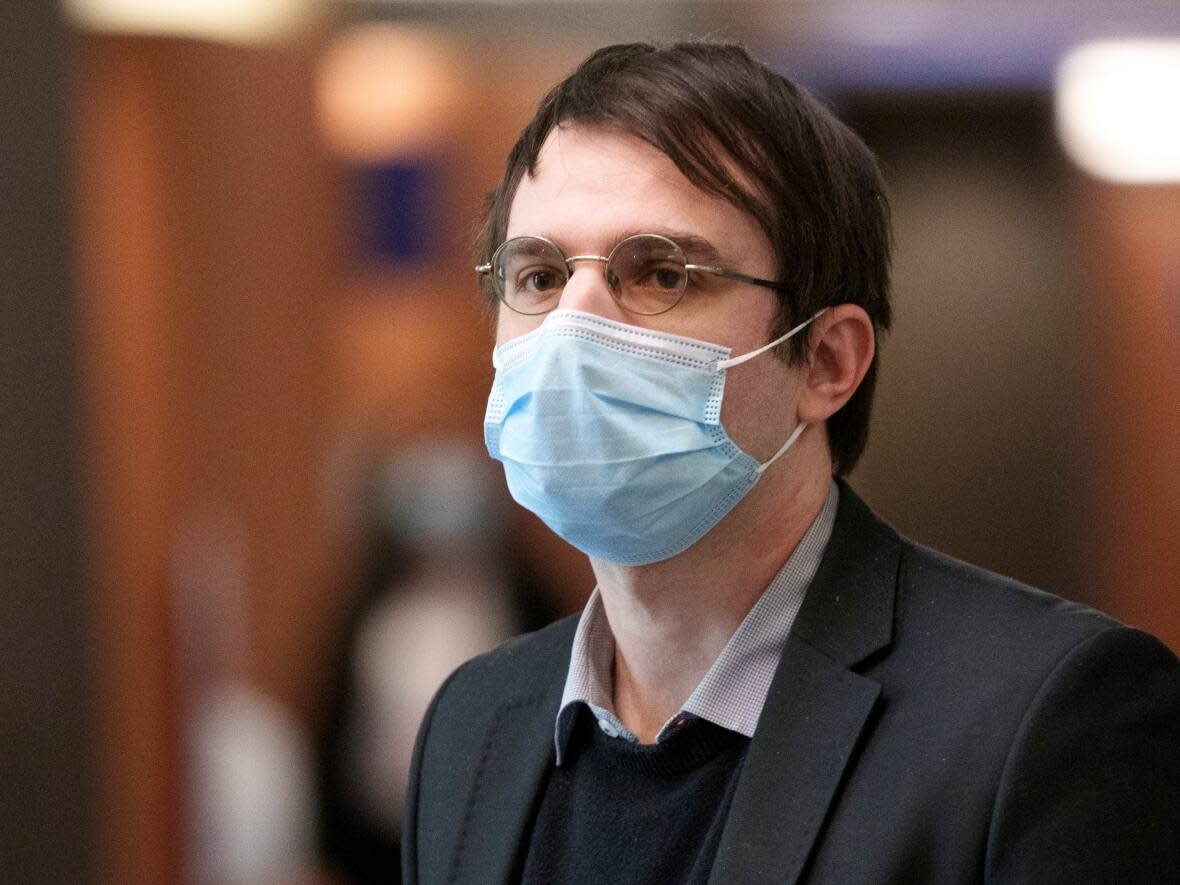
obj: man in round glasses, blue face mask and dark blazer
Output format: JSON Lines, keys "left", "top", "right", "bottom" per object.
{"left": 404, "top": 44, "right": 1180, "bottom": 885}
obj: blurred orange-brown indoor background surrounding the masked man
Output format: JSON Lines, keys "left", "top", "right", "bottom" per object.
{"left": 0, "top": 0, "right": 1180, "bottom": 885}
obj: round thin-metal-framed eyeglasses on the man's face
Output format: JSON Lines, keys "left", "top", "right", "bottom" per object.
{"left": 476, "top": 234, "right": 785, "bottom": 316}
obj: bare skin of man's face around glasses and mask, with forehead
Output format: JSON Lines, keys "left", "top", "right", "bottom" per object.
{"left": 496, "top": 125, "right": 798, "bottom": 460}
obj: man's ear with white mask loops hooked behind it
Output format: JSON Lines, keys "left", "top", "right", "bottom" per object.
{"left": 799, "top": 304, "right": 877, "bottom": 424}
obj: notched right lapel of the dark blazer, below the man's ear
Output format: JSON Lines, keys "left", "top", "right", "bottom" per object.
{"left": 709, "top": 484, "right": 902, "bottom": 885}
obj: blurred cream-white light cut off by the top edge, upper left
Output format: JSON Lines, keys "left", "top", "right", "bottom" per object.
{"left": 63, "top": 0, "right": 320, "bottom": 42}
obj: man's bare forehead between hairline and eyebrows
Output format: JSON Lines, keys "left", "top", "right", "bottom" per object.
{"left": 506, "top": 125, "right": 769, "bottom": 258}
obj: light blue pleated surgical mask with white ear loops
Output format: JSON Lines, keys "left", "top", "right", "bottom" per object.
{"left": 484, "top": 310, "right": 822, "bottom": 565}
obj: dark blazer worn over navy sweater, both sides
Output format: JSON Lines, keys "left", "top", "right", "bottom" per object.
{"left": 402, "top": 486, "right": 1180, "bottom": 885}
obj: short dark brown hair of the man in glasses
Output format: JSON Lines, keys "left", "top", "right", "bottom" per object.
{"left": 479, "top": 42, "right": 890, "bottom": 474}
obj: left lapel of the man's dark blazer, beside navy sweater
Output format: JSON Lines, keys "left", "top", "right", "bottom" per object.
{"left": 448, "top": 684, "right": 561, "bottom": 885}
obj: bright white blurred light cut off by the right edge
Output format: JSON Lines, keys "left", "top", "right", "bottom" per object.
{"left": 1056, "top": 40, "right": 1180, "bottom": 184}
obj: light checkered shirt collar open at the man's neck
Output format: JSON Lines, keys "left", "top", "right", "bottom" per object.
{"left": 555, "top": 481, "right": 840, "bottom": 765}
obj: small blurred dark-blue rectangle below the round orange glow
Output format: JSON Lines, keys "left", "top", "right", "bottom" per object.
{"left": 359, "top": 159, "right": 443, "bottom": 264}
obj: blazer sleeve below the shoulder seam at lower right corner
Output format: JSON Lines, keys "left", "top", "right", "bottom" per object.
{"left": 984, "top": 627, "right": 1180, "bottom": 885}
